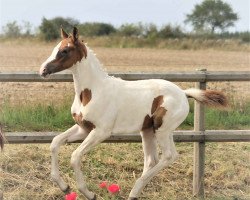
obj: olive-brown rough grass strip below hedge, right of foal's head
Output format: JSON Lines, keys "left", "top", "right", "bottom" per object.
{"left": 84, "top": 36, "right": 250, "bottom": 51}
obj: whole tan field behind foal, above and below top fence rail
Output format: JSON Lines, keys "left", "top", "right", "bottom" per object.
{"left": 0, "top": 42, "right": 250, "bottom": 104}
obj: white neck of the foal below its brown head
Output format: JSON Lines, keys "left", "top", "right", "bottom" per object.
{"left": 72, "top": 49, "right": 108, "bottom": 94}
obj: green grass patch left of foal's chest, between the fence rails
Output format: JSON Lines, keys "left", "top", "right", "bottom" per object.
{"left": 0, "top": 103, "right": 74, "bottom": 131}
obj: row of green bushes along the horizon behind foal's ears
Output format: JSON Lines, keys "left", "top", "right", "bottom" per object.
{"left": 2, "top": 17, "right": 250, "bottom": 42}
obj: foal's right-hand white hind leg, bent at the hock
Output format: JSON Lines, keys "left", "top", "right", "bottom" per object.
{"left": 129, "top": 131, "right": 178, "bottom": 200}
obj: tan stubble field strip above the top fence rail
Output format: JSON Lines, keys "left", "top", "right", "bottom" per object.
{"left": 0, "top": 43, "right": 250, "bottom": 71}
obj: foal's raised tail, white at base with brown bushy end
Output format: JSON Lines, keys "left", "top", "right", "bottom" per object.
{"left": 184, "top": 88, "right": 228, "bottom": 108}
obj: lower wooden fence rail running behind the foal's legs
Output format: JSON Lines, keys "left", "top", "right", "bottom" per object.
{"left": 5, "top": 130, "right": 250, "bottom": 144}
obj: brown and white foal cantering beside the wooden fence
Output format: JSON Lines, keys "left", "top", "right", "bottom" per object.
{"left": 40, "top": 28, "right": 226, "bottom": 200}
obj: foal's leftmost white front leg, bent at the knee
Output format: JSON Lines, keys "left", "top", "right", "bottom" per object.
{"left": 50, "top": 124, "right": 88, "bottom": 194}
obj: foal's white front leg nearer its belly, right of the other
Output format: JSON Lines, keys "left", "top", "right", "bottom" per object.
{"left": 71, "top": 128, "right": 111, "bottom": 200}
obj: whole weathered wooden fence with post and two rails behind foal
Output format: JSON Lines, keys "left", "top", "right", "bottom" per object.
{"left": 0, "top": 69, "right": 250, "bottom": 197}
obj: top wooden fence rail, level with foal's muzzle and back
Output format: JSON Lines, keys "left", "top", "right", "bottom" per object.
{"left": 0, "top": 71, "right": 250, "bottom": 82}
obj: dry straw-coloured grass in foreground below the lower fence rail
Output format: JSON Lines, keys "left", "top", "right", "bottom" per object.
{"left": 0, "top": 143, "right": 250, "bottom": 200}
